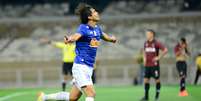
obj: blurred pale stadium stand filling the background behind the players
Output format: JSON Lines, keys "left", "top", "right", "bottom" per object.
{"left": 0, "top": 0, "right": 201, "bottom": 87}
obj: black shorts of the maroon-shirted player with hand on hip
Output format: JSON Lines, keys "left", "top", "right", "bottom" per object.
{"left": 144, "top": 66, "right": 160, "bottom": 79}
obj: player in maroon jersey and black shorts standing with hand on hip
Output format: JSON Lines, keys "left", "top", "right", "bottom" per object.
{"left": 141, "top": 29, "right": 168, "bottom": 101}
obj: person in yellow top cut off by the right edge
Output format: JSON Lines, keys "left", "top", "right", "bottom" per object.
{"left": 194, "top": 52, "right": 201, "bottom": 85}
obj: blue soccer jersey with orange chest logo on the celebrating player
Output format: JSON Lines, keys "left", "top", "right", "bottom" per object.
{"left": 74, "top": 24, "right": 102, "bottom": 67}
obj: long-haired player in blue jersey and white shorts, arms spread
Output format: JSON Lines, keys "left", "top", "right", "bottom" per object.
{"left": 38, "top": 4, "right": 116, "bottom": 101}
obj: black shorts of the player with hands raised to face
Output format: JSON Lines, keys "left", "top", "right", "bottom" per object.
{"left": 176, "top": 61, "right": 187, "bottom": 77}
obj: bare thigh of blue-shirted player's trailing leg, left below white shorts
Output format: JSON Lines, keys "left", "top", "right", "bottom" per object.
{"left": 70, "top": 85, "right": 82, "bottom": 101}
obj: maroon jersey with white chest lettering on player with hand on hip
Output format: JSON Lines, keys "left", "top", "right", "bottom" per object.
{"left": 144, "top": 40, "right": 165, "bottom": 67}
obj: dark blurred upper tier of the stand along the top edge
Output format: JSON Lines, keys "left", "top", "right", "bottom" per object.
{"left": 0, "top": 0, "right": 201, "bottom": 18}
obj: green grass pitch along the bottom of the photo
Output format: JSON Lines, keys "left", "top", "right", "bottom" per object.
{"left": 0, "top": 86, "right": 201, "bottom": 101}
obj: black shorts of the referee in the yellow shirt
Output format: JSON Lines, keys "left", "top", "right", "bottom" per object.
{"left": 62, "top": 62, "right": 73, "bottom": 75}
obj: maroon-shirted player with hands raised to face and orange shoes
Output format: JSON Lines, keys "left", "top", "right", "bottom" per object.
{"left": 174, "top": 38, "right": 190, "bottom": 96}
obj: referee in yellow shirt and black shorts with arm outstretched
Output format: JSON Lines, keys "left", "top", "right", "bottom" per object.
{"left": 41, "top": 38, "right": 76, "bottom": 91}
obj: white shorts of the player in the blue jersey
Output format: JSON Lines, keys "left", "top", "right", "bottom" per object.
{"left": 72, "top": 63, "right": 93, "bottom": 90}
